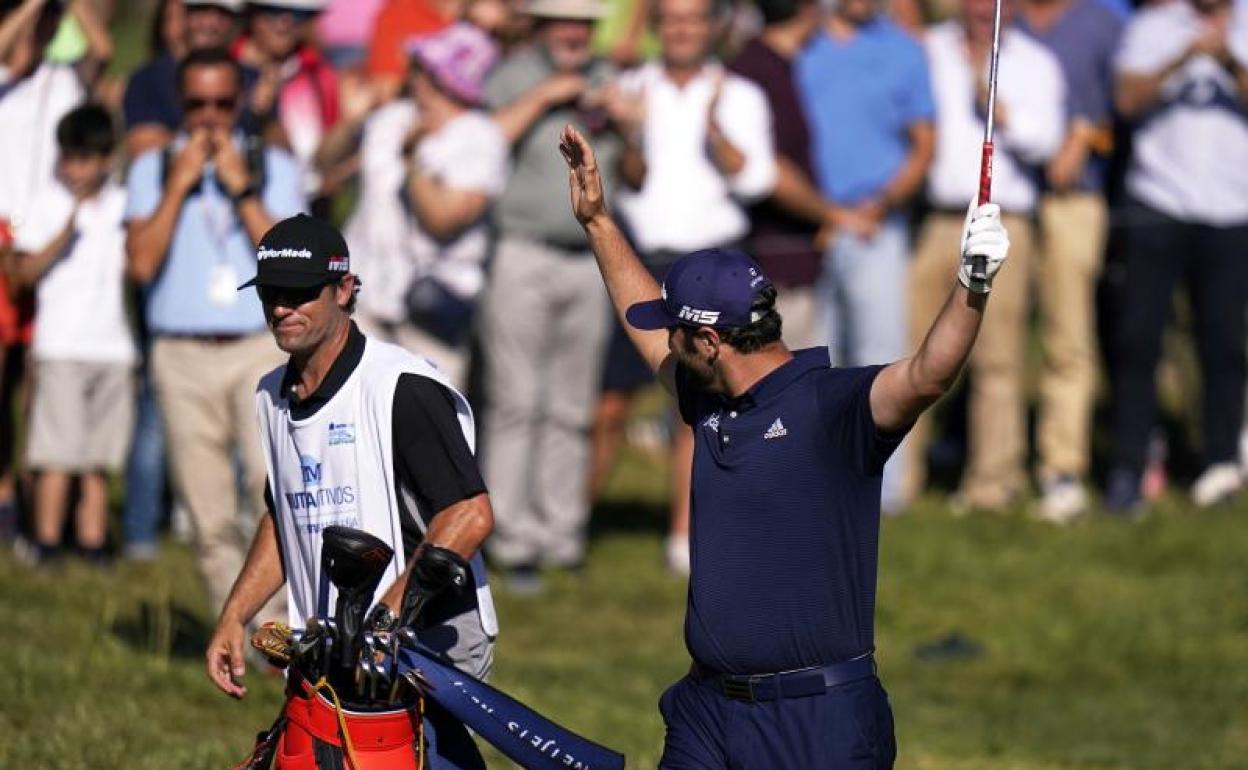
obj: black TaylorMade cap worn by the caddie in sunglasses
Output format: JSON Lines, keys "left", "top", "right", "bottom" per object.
{"left": 238, "top": 213, "right": 351, "bottom": 290}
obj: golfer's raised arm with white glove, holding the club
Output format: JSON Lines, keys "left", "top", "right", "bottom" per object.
{"left": 871, "top": 203, "right": 1010, "bottom": 432}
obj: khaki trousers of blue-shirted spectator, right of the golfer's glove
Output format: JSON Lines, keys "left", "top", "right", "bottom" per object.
{"left": 1036, "top": 192, "right": 1108, "bottom": 479}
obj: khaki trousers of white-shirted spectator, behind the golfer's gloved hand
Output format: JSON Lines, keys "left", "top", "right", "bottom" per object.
{"left": 906, "top": 212, "right": 1035, "bottom": 508}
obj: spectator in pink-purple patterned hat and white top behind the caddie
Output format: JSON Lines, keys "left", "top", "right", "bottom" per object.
{"left": 336, "top": 22, "right": 508, "bottom": 388}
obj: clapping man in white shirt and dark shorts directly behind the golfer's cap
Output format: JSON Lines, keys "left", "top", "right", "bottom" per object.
{"left": 600, "top": 0, "right": 776, "bottom": 572}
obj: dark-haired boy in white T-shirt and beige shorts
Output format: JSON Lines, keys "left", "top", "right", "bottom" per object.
{"left": 14, "top": 105, "right": 135, "bottom": 560}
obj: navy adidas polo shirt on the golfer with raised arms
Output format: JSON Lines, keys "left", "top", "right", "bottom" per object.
{"left": 676, "top": 348, "right": 901, "bottom": 674}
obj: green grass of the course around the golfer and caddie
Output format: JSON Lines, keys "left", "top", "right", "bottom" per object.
{"left": 0, "top": 446, "right": 1248, "bottom": 770}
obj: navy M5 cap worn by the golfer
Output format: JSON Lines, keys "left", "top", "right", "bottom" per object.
{"left": 625, "top": 248, "right": 771, "bottom": 329}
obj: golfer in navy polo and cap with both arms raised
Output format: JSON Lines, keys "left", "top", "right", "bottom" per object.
{"left": 559, "top": 126, "right": 1010, "bottom": 770}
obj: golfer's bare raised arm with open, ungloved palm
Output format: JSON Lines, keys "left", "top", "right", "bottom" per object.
{"left": 559, "top": 125, "right": 675, "bottom": 392}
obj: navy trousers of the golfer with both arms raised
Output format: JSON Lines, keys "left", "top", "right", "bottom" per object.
{"left": 659, "top": 675, "right": 897, "bottom": 770}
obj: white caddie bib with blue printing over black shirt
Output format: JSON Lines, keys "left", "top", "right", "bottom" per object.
{"left": 256, "top": 338, "right": 498, "bottom": 639}
